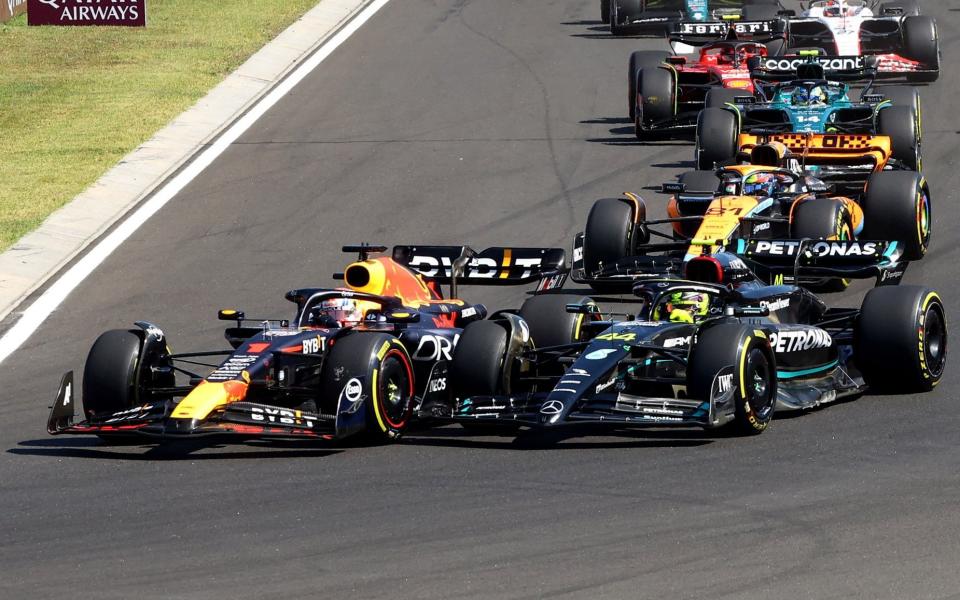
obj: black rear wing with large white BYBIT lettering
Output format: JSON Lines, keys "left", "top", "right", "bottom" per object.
{"left": 393, "top": 245, "right": 568, "bottom": 289}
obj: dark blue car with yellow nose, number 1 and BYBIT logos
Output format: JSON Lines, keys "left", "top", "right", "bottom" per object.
{"left": 47, "top": 245, "right": 565, "bottom": 441}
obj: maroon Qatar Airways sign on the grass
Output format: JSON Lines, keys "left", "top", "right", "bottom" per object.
{"left": 27, "top": 0, "right": 147, "bottom": 27}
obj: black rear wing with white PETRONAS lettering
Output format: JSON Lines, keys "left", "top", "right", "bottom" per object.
{"left": 728, "top": 239, "right": 909, "bottom": 285}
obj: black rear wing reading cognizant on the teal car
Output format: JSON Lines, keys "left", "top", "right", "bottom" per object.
{"left": 747, "top": 51, "right": 877, "bottom": 82}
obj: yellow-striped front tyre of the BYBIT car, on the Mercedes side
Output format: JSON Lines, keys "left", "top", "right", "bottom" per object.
{"left": 321, "top": 332, "right": 414, "bottom": 442}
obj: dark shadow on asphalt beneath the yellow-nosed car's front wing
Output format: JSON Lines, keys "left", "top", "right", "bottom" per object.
{"left": 7, "top": 438, "right": 342, "bottom": 461}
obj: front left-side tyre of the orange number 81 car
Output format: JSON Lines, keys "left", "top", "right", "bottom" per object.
{"left": 583, "top": 198, "right": 635, "bottom": 282}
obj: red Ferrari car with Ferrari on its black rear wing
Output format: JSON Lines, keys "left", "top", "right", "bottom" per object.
{"left": 627, "top": 20, "right": 785, "bottom": 139}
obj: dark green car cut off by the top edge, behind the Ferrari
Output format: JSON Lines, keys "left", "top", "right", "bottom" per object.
{"left": 600, "top": 0, "right": 780, "bottom": 35}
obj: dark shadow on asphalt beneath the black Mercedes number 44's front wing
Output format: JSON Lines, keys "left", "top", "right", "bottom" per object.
{"left": 402, "top": 426, "right": 712, "bottom": 451}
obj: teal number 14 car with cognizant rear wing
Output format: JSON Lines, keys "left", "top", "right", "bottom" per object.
{"left": 695, "top": 55, "right": 922, "bottom": 170}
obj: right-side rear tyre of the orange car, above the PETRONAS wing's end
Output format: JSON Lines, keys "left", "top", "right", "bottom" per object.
{"left": 860, "top": 171, "right": 932, "bottom": 260}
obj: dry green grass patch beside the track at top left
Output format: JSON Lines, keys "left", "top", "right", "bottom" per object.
{"left": 0, "top": 0, "right": 317, "bottom": 249}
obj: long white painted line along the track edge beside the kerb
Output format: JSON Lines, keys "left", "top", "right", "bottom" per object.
{"left": 0, "top": 0, "right": 390, "bottom": 362}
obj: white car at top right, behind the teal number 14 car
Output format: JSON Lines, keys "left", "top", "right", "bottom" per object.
{"left": 788, "top": 0, "right": 940, "bottom": 82}
